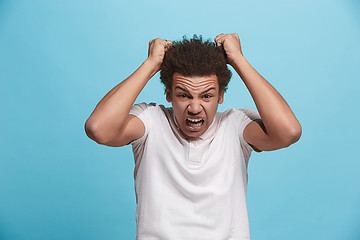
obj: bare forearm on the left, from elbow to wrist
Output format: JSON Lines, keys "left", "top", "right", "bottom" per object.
{"left": 85, "top": 60, "right": 158, "bottom": 139}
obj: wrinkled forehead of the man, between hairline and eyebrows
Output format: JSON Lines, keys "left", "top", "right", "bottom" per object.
{"left": 172, "top": 73, "right": 219, "bottom": 90}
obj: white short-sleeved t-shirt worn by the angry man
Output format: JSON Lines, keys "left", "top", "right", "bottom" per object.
{"left": 130, "top": 103, "right": 260, "bottom": 240}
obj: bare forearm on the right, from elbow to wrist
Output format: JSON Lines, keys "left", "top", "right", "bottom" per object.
{"left": 232, "top": 56, "right": 301, "bottom": 141}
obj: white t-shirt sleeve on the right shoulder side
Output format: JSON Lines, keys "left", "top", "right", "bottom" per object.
{"left": 234, "top": 108, "right": 261, "bottom": 156}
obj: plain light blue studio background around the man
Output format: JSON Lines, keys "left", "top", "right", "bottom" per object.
{"left": 0, "top": 0, "right": 360, "bottom": 240}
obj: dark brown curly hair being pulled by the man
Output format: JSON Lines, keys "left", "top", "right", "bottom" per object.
{"left": 160, "top": 34, "right": 231, "bottom": 91}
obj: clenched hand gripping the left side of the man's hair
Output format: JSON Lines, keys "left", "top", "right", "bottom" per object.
{"left": 147, "top": 38, "right": 173, "bottom": 71}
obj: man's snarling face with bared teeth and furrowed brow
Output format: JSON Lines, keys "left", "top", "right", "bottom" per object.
{"left": 166, "top": 73, "right": 224, "bottom": 137}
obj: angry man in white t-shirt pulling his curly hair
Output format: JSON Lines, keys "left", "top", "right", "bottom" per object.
{"left": 85, "top": 33, "right": 301, "bottom": 240}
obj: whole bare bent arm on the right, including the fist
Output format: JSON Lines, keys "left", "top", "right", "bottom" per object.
{"left": 215, "top": 33, "right": 302, "bottom": 151}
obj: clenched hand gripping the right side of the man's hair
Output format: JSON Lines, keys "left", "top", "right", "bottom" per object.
{"left": 215, "top": 33, "right": 243, "bottom": 66}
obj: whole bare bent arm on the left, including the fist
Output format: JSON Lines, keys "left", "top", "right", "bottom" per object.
{"left": 85, "top": 38, "right": 172, "bottom": 146}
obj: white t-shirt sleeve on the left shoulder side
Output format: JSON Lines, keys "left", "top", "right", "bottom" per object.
{"left": 129, "top": 102, "right": 154, "bottom": 145}
